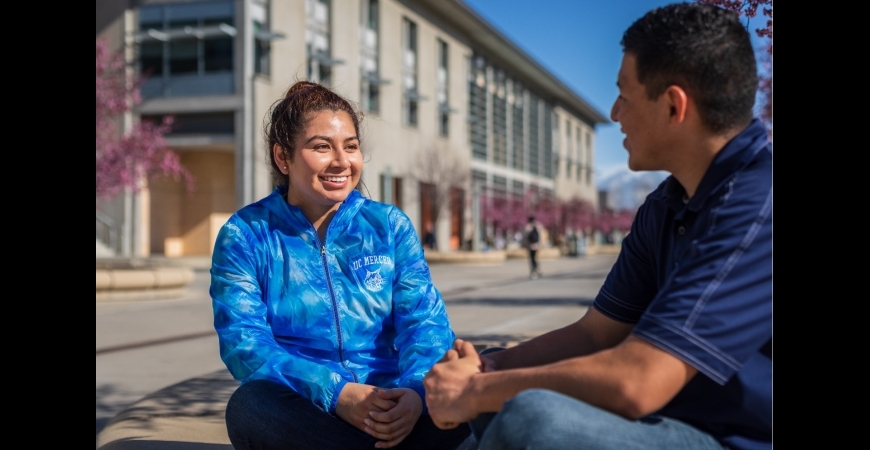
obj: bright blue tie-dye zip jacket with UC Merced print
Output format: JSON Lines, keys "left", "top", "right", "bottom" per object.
{"left": 210, "top": 187, "right": 455, "bottom": 413}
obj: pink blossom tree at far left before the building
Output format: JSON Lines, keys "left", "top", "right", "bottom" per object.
{"left": 96, "top": 39, "right": 193, "bottom": 199}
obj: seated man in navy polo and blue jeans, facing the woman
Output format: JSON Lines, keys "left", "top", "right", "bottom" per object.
{"left": 424, "top": 4, "right": 773, "bottom": 450}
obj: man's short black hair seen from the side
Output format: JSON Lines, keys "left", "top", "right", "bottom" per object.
{"left": 621, "top": 3, "right": 758, "bottom": 133}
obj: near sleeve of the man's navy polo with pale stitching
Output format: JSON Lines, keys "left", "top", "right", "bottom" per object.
{"left": 633, "top": 171, "right": 773, "bottom": 384}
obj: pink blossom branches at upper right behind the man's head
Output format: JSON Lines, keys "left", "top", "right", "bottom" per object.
{"left": 697, "top": 0, "right": 773, "bottom": 140}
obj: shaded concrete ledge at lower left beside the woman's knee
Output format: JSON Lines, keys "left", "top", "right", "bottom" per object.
{"left": 97, "top": 370, "right": 239, "bottom": 450}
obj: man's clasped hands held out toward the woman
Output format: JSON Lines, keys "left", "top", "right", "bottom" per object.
{"left": 423, "top": 339, "right": 484, "bottom": 430}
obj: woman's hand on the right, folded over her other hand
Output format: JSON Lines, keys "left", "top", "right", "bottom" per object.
{"left": 364, "top": 388, "right": 423, "bottom": 448}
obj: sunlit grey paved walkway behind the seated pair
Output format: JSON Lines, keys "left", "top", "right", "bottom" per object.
{"left": 96, "top": 255, "right": 615, "bottom": 448}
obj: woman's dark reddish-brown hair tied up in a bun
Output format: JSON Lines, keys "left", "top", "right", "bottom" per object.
{"left": 264, "top": 81, "right": 362, "bottom": 186}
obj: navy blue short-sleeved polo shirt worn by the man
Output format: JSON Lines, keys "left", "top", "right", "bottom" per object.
{"left": 593, "top": 120, "right": 773, "bottom": 449}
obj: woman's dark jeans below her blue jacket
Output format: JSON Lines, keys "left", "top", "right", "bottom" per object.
{"left": 226, "top": 380, "right": 471, "bottom": 450}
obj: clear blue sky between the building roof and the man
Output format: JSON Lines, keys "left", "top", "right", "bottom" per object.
{"left": 465, "top": 0, "right": 759, "bottom": 180}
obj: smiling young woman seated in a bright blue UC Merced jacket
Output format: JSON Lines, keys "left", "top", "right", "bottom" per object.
{"left": 211, "top": 82, "right": 469, "bottom": 449}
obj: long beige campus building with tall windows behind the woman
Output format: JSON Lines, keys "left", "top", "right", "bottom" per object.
{"left": 97, "top": 0, "right": 607, "bottom": 256}
